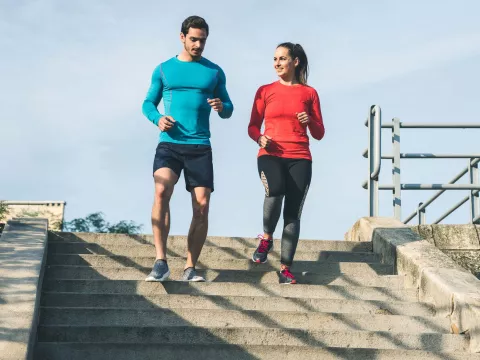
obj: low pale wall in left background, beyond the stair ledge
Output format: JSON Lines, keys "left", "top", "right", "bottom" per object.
{"left": 2, "top": 201, "right": 66, "bottom": 231}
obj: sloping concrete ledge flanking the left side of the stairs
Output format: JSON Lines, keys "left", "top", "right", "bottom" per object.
{"left": 0, "top": 218, "right": 48, "bottom": 360}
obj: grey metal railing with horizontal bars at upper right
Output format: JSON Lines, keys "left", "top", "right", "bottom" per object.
{"left": 362, "top": 105, "right": 480, "bottom": 224}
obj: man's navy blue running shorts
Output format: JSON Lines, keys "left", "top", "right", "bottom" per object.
{"left": 153, "top": 142, "right": 213, "bottom": 192}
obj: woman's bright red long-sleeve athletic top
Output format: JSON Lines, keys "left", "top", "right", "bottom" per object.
{"left": 248, "top": 81, "right": 325, "bottom": 160}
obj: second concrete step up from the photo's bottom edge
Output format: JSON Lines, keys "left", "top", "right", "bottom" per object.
{"left": 38, "top": 324, "right": 468, "bottom": 353}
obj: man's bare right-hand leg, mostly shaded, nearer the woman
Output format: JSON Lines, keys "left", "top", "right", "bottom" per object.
{"left": 185, "top": 187, "right": 211, "bottom": 269}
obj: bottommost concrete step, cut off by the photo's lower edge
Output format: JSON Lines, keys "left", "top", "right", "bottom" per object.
{"left": 35, "top": 342, "right": 480, "bottom": 360}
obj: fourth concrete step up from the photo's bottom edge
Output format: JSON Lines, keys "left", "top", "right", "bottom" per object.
{"left": 41, "top": 292, "right": 435, "bottom": 316}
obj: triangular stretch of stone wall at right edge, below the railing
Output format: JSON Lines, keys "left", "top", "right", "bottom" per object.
{"left": 411, "top": 224, "right": 480, "bottom": 279}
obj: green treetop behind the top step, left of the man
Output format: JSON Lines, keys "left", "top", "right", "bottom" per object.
{"left": 63, "top": 212, "right": 143, "bottom": 235}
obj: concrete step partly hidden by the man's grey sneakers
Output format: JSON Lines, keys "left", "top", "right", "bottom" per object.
{"left": 45, "top": 265, "right": 394, "bottom": 288}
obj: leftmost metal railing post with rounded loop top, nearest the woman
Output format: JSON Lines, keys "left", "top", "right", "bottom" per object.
{"left": 367, "top": 105, "right": 382, "bottom": 216}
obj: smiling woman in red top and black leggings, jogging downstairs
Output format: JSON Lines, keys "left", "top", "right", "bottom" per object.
{"left": 248, "top": 42, "right": 325, "bottom": 284}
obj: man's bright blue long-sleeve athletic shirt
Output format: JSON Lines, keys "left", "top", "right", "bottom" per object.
{"left": 142, "top": 57, "right": 233, "bottom": 145}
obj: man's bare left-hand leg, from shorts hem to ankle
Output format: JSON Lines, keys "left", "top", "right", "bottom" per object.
{"left": 152, "top": 168, "right": 178, "bottom": 260}
